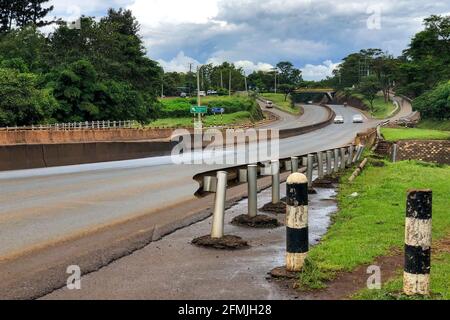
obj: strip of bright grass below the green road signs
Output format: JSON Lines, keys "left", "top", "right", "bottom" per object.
{"left": 148, "top": 111, "right": 252, "bottom": 128}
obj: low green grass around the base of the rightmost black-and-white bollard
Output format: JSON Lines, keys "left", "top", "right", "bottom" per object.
{"left": 352, "top": 252, "right": 450, "bottom": 300}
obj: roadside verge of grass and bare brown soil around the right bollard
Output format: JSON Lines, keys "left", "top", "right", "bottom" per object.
{"left": 297, "top": 154, "right": 450, "bottom": 299}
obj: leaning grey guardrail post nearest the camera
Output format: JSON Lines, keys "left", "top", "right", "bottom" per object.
{"left": 211, "top": 171, "right": 228, "bottom": 239}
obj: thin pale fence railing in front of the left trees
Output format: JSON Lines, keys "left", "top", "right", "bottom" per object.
{"left": 0, "top": 120, "right": 140, "bottom": 131}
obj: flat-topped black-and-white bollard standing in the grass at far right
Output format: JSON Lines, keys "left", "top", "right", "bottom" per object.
{"left": 403, "top": 190, "right": 433, "bottom": 295}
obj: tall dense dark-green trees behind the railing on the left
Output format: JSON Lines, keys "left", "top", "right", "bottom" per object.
{"left": 0, "top": 6, "right": 163, "bottom": 126}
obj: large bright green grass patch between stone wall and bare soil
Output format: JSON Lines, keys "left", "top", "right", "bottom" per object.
{"left": 298, "top": 161, "right": 450, "bottom": 296}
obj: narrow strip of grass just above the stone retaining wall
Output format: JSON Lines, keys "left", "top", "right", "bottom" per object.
{"left": 381, "top": 128, "right": 450, "bottom": 141}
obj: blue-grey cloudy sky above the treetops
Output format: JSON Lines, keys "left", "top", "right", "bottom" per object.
{"left": 50, "top": 0, "right": 450, "bottom": 80}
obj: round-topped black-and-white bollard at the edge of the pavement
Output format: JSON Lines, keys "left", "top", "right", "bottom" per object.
{"left": 286, "top": 173, "right": 309, "bottom": 272}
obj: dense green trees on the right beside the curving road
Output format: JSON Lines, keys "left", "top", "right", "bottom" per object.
{"left": 319, "top": 15, "right": 450, "bottom": 119}
